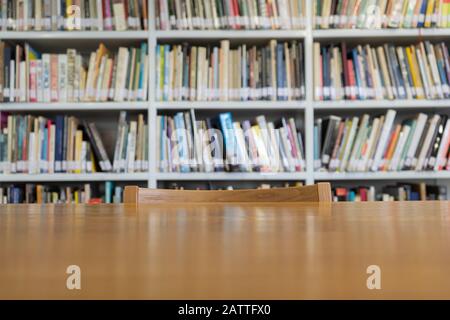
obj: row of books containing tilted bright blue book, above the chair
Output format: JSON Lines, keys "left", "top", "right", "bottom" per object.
{"left": 157, "top": 110, "right": 305, "bottom": 173}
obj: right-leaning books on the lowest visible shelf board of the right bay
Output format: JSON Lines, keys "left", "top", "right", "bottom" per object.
{"left": 314, "top": 110, "right": 450, "bottom": 172}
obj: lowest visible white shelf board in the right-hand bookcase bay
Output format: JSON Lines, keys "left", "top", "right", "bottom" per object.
{"left": 314, "top": 171, "right": 450, "bottom": 181}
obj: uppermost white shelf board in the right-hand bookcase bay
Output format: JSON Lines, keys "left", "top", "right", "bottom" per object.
{"left": 312, "top": 28, "right": 450, "bottom": 40}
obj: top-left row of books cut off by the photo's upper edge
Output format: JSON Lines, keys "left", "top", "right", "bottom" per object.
{"left": 0, "top": 0, "right": 148, "bottom": 31}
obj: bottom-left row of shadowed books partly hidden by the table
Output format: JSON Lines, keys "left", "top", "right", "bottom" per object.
{"left": 0, "top": 181, "right": 123, "bottom": 204}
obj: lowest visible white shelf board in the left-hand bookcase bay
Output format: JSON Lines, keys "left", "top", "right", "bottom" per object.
{"left": 0, "top": 173, "right": 149, "bottom": 182}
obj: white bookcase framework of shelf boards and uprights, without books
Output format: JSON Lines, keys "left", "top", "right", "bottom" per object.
{"left": 0, "top": 0, "right": 450, "bottom": 199}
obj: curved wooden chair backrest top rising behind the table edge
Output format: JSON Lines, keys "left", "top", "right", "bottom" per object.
{"left": 124, "top": 182, "right": 331, "bottom": 203}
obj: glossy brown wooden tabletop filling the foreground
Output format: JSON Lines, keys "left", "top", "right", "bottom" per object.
{"left": 0, "top": 202, "right": 450, "bottom": 299}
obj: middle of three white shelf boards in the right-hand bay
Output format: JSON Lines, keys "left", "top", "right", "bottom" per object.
{"left": 313, "top": 100, "right": 450, "bottom": 110}
